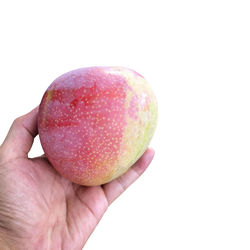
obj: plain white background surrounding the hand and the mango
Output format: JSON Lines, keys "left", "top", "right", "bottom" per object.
{"left": 0, "top": 0, "right": 250, "bottom": 250}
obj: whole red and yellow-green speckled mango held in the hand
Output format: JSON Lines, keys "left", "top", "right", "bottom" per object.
{"left": 38, "top": 67, "right": 158, "bottom": 186}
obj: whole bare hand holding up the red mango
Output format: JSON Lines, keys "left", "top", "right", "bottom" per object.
{"left": 0, "top": 108, "right": 154, "bottom": 250}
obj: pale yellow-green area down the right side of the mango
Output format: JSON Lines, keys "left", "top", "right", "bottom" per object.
{"left": 108, "top": 69, "right": 158, "bottom": 179}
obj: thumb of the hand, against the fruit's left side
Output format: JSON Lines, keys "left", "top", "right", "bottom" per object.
{"left": 2, "top": 107, "right": 38, "bottom": 159}
